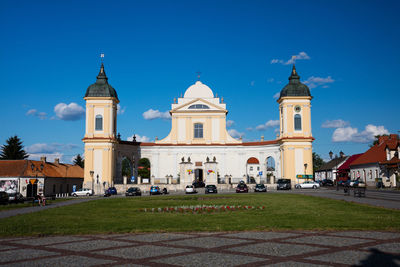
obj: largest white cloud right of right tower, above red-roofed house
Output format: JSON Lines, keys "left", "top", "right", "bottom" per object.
{"left": 332, "top": 124, "right": 389, "bottom": 143}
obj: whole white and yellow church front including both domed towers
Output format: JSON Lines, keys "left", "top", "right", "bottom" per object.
{"left": 83, "top": 64, "right": 314, "bottom": 193}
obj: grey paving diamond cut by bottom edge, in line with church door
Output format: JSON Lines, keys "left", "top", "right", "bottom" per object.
{"left": 152, "top": 252, "right": 266, "bottom": 267}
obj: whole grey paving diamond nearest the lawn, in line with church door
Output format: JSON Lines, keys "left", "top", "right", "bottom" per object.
{"left": 165, "top": 237, "right": 248, "bottom": 248}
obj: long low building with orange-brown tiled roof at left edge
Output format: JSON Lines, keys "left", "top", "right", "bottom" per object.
{"left": 0, "top": 157, "right": 83, "bottom": 197}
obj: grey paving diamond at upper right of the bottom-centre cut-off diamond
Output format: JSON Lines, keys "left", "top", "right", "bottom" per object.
{"left": 228, "top": 243, "right": 320, "bottom": 256}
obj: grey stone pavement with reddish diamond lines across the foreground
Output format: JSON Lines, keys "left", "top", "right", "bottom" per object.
{"left": 0, "top": 231, "right": 400, "bottom": 267}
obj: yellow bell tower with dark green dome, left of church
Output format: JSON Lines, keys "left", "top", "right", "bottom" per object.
{"left": 82, "top": 63, "right": 119, "bottom": 194}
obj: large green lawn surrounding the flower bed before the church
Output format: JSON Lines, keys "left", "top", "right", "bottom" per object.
{"left": 0, "top": 194, "right": 400, "bottom": 236}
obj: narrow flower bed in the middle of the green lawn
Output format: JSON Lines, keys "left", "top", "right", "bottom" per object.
{"left": 139, "top": 205, "right": 265, "bottom": 213}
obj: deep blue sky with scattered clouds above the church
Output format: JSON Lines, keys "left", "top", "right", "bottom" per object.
{"left": 0, "top": 1, "right": 400, "bottom": 162}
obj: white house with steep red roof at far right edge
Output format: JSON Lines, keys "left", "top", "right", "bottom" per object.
{"left": 350, "top": 134, "right": 400, "bottom": 187}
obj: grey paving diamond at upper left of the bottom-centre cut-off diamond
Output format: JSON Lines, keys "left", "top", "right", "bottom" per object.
{"left": 94, "top": 246, "right": 190, "bottom": 259}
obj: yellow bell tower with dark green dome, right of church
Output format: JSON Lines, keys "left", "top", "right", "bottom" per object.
{"left": 277, "top": 65, "right": 314, "bottom": 183}
